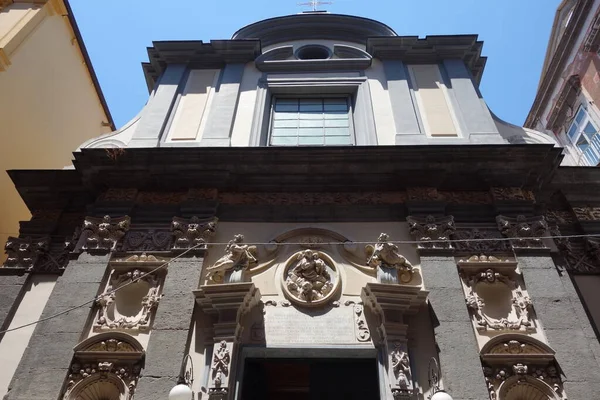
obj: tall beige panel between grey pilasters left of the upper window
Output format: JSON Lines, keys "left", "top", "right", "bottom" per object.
{"left": 167, "top": 69, "right": 217, "bottom": 140}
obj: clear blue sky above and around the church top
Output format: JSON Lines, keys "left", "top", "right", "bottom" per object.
{"left": 70, "top": 0, "right": 560, "bottom": 127}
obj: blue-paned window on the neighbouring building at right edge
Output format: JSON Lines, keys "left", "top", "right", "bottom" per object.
{"left": 567, "top": 107, "right": 600, "bottom": 166}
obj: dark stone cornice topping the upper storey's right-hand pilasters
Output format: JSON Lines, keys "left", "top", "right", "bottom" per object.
{"left": 367, "top": 35, "right": 487, "bottom": 83}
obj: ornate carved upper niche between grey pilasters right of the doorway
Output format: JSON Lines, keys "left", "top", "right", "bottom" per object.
{"left": 458, "top": 256, "right": 536, "bottom": 332}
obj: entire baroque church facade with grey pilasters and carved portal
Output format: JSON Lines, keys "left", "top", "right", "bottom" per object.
{"left": 0, "top": 12, "right": 600, "bottom": 400}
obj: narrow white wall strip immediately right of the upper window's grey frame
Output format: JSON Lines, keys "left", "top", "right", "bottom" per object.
{"left": 365, "top": 59, "right": 396, "bottom": 145}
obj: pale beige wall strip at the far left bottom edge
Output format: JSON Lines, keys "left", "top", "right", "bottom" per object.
{"left": 0, "top": 275, "right": 58, "bottom": 395}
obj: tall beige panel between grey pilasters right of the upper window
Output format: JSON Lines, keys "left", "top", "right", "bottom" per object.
{"left": 410, "top": 65, "right": 457, "bottom": 136}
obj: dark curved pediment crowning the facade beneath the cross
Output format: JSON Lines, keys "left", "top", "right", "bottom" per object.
{"left": 232, "top": 12, "right": 398, "bottom": 47}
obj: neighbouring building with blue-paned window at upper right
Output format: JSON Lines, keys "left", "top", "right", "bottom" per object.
{"left": 525, "top": 0, "right": 600, "bottom": 166}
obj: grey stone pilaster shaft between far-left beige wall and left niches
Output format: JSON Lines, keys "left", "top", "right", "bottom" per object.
{"left": 4, "top": 254, "right": 109, "bottom": 400}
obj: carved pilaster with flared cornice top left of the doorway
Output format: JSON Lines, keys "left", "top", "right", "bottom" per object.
{"left": 194, "top": 283, "right": 260, "bottom": 400}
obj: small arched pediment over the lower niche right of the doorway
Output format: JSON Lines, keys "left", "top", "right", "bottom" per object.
{"left": 481, "top": 333, "right": 555, "bottom": 364}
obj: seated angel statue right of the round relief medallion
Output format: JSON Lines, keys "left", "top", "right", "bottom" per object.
{"left": 365, "top": 233, "right": 413, "bottom": 283}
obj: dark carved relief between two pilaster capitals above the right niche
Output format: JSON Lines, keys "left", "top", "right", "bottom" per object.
{"left": 452, "top": 227, "right": 511, "bottom": 254}
